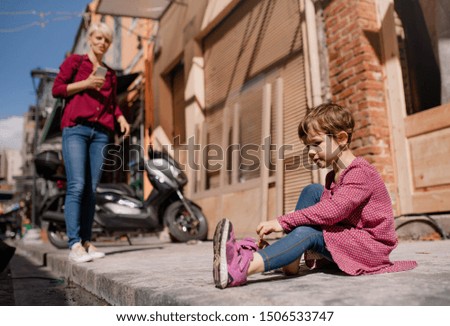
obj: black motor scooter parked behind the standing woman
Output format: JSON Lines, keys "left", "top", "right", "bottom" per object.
{"left": 36, "top": 146, "right": 208, "bottom": 248}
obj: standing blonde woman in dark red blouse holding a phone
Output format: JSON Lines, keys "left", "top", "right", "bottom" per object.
{"left": 53, "top": 23, "right": 130, "bottom": 263}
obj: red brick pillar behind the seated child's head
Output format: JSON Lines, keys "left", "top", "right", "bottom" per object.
{"left": 324, "top": 0, "right": 398, "bottom": 213}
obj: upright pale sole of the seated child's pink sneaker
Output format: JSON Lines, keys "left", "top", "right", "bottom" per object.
{"left": 213, "top": 219, "right": 231, "bottom": 289}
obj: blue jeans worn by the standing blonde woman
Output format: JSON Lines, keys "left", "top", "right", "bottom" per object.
{"left": 62, "top": 125, "right": 109, "bottom": 248}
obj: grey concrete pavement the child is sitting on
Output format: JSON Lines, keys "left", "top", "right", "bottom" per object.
{"left": 9, "top": 236, "right": 450, "bottom": 306}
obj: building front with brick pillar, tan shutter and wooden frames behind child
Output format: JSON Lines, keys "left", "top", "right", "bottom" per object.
{"left": 92, "top": 0, "right": 450, "bottom": 236}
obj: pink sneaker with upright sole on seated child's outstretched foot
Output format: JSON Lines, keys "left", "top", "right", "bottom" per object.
{"left": 213, "top": 219, "right": 258, "bottom": 289}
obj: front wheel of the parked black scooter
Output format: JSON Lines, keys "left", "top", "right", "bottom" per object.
{"left": 164, "top": 201, "right": 208, "bottom": 242}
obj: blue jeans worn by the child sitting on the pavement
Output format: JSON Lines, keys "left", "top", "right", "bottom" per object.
{"left": 258, "top": 184, "right": 333, "bottom": 271}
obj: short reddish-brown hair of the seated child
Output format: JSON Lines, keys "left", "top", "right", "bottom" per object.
{"left": 298, "top": 103, "right": 355, "bottom": 144}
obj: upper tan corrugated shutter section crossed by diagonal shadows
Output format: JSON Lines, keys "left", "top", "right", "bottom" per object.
{"left": 203, "top": 0, "right": 301, "bottom": 107}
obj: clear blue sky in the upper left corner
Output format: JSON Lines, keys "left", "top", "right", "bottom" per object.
{"left": 0, "top": 0, "right": 91, "bottom": 120}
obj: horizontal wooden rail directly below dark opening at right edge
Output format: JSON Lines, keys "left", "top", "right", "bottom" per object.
{"left": 405, "top": 103, "right": 450, "bottom": 138}
